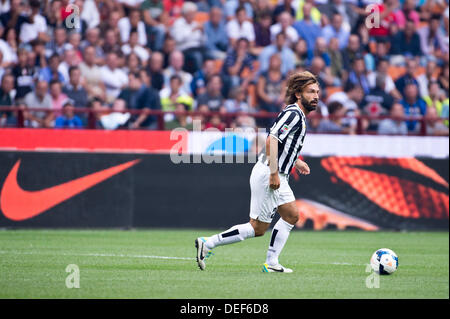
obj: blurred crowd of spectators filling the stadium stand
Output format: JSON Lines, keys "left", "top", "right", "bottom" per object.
{"left": 0, "top": 0, "right": 449, "bottom": 135}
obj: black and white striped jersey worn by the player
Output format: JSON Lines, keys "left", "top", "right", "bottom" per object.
{"left": 260, "top": 103, "right": 306, "bottom": 174}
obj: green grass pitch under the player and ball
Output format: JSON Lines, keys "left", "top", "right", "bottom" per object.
{"left": 0, "top": 230, "right": 449, "bottom": 299}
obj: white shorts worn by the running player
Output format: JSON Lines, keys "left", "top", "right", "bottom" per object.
{"left": 250, "top": 161, "right": 295, "bottom": 223}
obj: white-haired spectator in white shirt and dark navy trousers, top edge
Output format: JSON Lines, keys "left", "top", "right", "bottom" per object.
{"left": 170, "top": 1, "right": 206, "bottom": 73}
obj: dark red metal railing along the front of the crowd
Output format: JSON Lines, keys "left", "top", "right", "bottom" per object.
{"left": 0, "top": 106, "right": 449, "bottom": 136}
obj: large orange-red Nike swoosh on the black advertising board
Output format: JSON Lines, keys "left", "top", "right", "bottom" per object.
{"left": 0, "top": 159, "right": 140, "bottom": 221}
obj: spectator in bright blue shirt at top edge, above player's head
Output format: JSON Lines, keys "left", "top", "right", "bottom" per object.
{"left": 293, "top": 1, "right": 322, "bottom": 53}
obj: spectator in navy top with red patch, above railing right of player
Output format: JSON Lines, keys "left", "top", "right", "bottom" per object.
{"left": 362, "top": 74, "right": 394, "bottom": 131}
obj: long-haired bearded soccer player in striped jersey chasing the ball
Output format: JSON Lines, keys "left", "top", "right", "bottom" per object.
{"left": 195, "top": 71, "right": 319, "bottom": 273}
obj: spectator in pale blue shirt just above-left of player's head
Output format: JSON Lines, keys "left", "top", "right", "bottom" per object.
{"left": 259, "top": 32, "right": 295, "bottom": 75}
